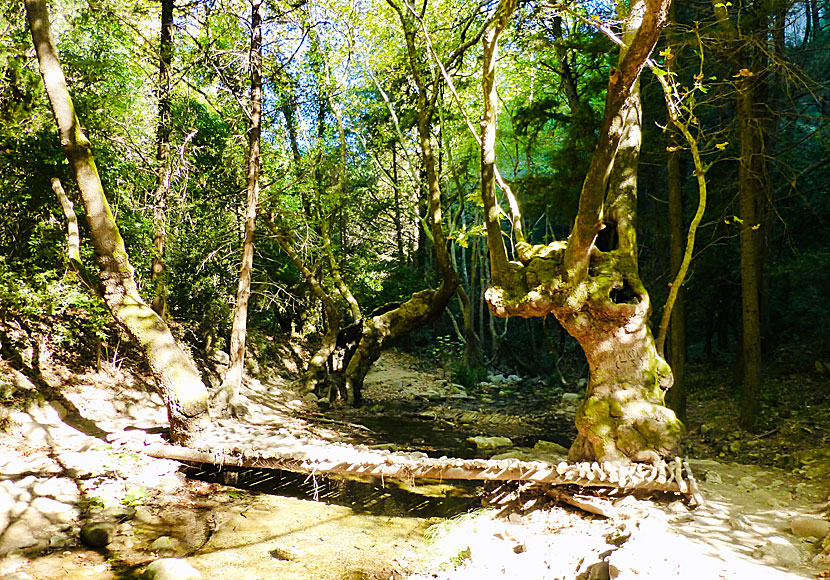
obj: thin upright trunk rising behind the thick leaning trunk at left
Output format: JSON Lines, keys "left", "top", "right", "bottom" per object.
{"left": 150, "top": 0, "right": 173, "bottom": 318}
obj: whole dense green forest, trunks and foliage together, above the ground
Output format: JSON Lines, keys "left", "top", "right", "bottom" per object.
{"left": 0, "top": 0, "right": 830, "bottom": 578}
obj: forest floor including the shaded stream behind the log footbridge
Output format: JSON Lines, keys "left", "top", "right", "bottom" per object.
{"left": 0, "top": 352, "right": 830, "bottom": 580}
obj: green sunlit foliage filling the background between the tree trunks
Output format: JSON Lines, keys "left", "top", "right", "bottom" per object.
{"left": 0, "top": 0, "right": 830, "bottom": 432}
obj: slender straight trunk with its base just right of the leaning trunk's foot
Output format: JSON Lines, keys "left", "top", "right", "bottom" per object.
{"left": 221, "top": 0, "right": 262, "bottom": 415}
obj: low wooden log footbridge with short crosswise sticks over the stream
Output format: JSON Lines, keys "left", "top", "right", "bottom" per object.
{"left": 115, "top": 424, "right": 702, "bottom": 504}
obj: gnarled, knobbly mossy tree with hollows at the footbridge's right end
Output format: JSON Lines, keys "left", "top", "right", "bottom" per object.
{"left": 482, "top": 0, "right": 683, "bottom": 462}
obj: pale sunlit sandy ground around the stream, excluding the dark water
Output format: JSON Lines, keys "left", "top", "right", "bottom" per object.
{"left": 0, "top": 355, "right": 830, "bottom": 580}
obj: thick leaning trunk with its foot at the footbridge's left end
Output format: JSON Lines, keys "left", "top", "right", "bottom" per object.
{"left": 26, "top": 0, "right": 210, "bottom": 445}
